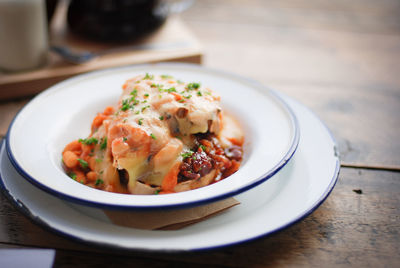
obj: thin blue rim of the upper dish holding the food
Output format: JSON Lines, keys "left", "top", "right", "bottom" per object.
{"left": 5, "top": 63, "right": 300, "bottom": 210}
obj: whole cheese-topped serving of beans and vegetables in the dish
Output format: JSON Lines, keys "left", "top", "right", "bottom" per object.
{"left": 62, "top": 73, "right": 244, "bottom": 194}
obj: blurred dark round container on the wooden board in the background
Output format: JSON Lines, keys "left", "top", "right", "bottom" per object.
{"left": 67, "top": 0, "right": 168, "bottom": 41}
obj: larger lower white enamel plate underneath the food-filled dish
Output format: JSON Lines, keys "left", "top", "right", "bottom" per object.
{"left": 0, "top": 94, "right": 339, "bottom": 251}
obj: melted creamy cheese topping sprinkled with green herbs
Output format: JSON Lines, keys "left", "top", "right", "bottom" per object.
{"left": 93, "top": 75, "right": 221, "bottom": 193}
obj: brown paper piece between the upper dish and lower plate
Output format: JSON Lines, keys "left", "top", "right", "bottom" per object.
{"left": 104, "top": 198, "right": 240, "bottom": 230}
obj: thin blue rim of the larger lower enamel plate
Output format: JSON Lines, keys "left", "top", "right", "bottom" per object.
{"left": 0, "top": 95, "right": 340, "bottom": 253}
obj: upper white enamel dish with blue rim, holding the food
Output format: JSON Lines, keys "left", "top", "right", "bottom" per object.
{"left": 6, "top": 64, "right": 299, "bottom": 209}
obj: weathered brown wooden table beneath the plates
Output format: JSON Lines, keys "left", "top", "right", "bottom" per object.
{"left": 0, "top": 0, "right": 400, "bottom": 267}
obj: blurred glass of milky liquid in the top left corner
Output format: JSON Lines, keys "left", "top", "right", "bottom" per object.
{"left": 0, "top": 0, "right": 48, "bottom": 71}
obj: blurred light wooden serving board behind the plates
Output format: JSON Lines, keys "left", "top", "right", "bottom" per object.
{"left": 0, "top": 1, "right": 202, "bottom": 100}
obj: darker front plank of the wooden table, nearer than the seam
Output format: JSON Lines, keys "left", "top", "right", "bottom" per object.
{"left": 0, "top": 168, "right": 400, "bottom": 267}
